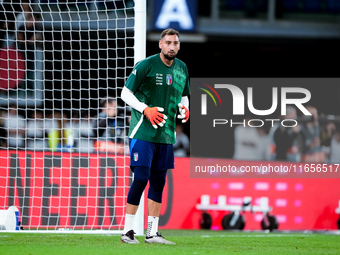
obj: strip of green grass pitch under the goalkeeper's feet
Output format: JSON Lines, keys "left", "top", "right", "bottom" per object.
{"left": 0, "top": 230, "right": 340, "bottom": 255}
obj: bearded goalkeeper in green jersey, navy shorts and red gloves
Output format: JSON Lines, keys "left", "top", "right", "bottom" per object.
{"left": 121, "top": 28, "right": 190, "bottom": 244}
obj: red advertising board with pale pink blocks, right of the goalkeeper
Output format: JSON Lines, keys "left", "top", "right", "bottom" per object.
{"left": 161, "top": 158, "right": 340, "bottom": 230}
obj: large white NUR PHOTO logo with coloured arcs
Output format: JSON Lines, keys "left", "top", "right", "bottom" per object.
{"left": 196, "top": 82, "right": 312, "bottom": 128}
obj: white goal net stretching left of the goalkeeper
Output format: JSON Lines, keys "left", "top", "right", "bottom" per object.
{"left": 0, "top": 0, "right": 146, "bottom": 233}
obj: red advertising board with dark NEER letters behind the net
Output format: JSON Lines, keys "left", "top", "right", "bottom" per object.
{"left": 0, "top": 151, "right": 131, "bottom": 229}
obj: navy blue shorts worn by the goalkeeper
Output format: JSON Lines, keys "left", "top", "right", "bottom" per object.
{"left": 129, "top": 139, "right": 175, "bottom": 171}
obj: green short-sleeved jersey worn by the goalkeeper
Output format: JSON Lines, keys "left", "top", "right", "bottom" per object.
{"left": 125, "top": 54, "right": 190, "bottom": 144}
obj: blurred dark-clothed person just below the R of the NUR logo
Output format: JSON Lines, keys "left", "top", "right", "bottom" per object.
{"left": 269, "top": 107, "right": 303, "bottom": 162}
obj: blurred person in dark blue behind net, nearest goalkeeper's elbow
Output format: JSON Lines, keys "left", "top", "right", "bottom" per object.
{"left": 93, "top": 98, "right": 125, "bottom": 143}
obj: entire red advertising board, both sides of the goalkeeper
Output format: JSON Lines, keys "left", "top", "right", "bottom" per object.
{"left": 0, "top": 151, "right": 340, "bottom": 230}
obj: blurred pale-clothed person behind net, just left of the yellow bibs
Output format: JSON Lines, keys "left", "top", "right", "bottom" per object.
{"left": 26, "top": 109, "right": 48, "bottom": 151}
